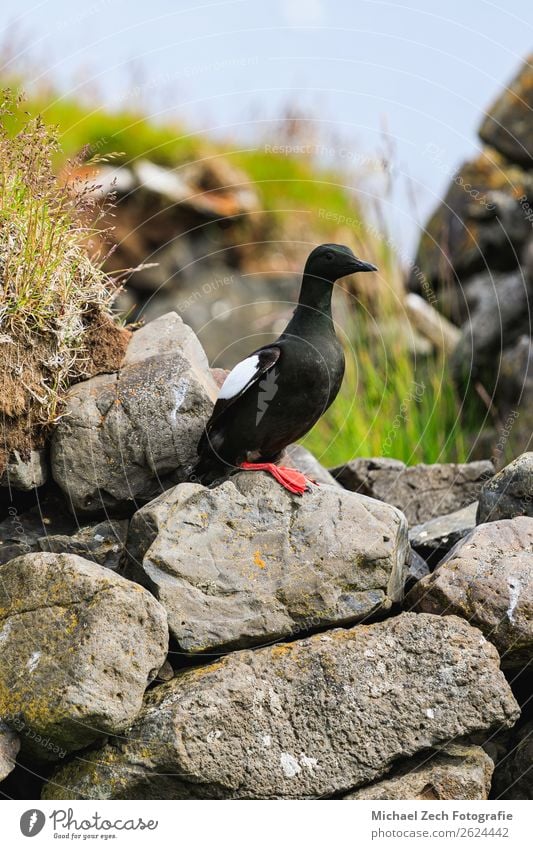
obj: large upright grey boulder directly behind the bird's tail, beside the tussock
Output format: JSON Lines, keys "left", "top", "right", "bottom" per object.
{"left": 51, "top": 313, "right": 217, "bottom": 513}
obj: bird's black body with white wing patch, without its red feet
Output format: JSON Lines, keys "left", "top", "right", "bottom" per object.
{"left": 190, "top": 245, "right": 376, "bottom": 485}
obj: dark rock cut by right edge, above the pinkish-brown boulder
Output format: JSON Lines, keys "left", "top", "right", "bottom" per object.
{"left": 477, "top": 451, "right": 533, "bottom": 523}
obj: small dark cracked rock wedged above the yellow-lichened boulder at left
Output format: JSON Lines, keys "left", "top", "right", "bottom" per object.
{"left": 37, "top": 519, "right": 129, "bottom": 572}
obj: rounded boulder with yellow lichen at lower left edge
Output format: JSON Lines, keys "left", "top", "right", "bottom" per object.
{"left": 0, "top": 553, "right": 168, "bottom": 760}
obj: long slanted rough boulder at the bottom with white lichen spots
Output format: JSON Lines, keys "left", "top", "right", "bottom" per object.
{"left": 43, "top": 614, "right": 519, "bottom": 799}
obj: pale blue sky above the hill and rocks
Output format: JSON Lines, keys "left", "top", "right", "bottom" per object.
{"left": 0, "top": 0, "right": 533, "bottom": 251}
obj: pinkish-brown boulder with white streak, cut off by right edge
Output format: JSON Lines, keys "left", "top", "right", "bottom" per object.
{"left": 405, "top": 516, "right": 533, "bottom": 668}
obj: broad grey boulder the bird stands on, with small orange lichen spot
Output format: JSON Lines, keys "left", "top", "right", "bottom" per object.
{"left": 128, "top": 472, "right": 407, "bottom": 652}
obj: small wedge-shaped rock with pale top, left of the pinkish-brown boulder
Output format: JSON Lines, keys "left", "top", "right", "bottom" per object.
{"left": 409, "top": 501, "right": 477, "bottom": 565}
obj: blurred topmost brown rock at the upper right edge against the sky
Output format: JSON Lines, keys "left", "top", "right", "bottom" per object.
{"left": 479, "top": 54, "right": 533, "bottom": 168}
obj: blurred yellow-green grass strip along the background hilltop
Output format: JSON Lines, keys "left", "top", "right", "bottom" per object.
{"left": 7, "top": 81, "right": 364, "bottom": 230}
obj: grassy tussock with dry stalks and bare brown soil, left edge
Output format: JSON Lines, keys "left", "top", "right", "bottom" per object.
{"left": 0, "top": 90, "right": 127, "bottom": 471}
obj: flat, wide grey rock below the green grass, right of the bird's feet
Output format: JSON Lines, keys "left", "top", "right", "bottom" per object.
{"left": 330, "top": 457, "right": 494, "bottom": 525}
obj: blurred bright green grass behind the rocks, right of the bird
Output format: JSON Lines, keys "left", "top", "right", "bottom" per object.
{"left": 303, "top": 302, "right": 476, "bottom": 467}
